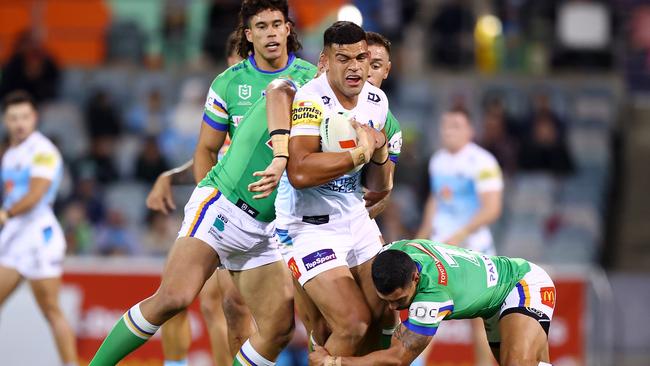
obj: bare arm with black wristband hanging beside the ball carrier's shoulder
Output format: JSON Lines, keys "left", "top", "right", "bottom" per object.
{"left": 248, "top": 79, "right": 296, "bottom": 199}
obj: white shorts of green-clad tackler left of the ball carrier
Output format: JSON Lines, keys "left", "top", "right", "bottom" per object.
{"left": 178, "top": 187, "right": 282, "bottom": 271}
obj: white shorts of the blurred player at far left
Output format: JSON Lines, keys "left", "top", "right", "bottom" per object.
{"left": 0, "top": 210, "right": 65, "bottom": 280}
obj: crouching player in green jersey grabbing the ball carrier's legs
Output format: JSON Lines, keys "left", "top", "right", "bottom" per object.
{"left": 309, "top": 240, "right": 556, "bottom": 366}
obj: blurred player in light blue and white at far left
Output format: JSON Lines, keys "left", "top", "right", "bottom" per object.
{"left": 0, "top": 91, "right": 77, "bottom": 366}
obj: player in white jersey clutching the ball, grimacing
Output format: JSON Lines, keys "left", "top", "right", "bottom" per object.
{"left": 276, "top": 22, "right": 392, "bottom": 355}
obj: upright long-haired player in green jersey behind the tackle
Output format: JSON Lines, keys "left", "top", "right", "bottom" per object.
{"left": 142, "top": 0, "right": 316, "bottom": 364}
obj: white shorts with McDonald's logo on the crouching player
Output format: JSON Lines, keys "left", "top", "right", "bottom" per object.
{"left": 485, "top": 263, "right": 556, "bottom": 347}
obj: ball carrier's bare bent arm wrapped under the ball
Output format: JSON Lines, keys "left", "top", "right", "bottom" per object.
{"left": 287, "top": 124, "right": 375, "bottom": 189}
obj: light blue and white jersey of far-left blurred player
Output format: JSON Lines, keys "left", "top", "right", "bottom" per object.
{"left": 2, "top": 131, "right": 63, "bottom": 210}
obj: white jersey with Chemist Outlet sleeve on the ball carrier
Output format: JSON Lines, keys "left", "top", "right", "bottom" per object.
{"left": 275, "top": 74, "right": 388, "bottom": 221}
